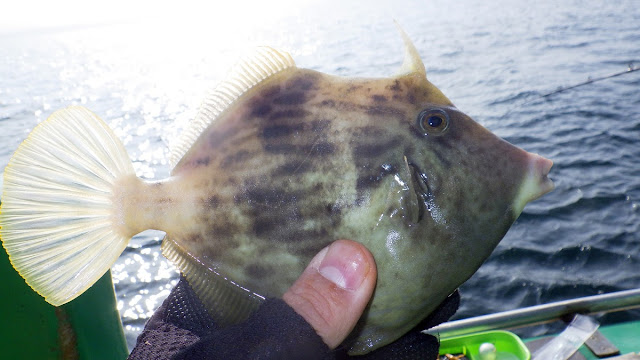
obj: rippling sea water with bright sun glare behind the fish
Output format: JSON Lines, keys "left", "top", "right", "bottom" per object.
{"left": 0, "top": 0, "right": 640, "bottom": 347}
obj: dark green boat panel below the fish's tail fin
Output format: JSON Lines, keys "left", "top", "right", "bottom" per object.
{"left": 0, "top": 240, "right": 128, "bottom": 360}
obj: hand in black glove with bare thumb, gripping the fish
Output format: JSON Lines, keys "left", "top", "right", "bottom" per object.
{"left": 129, "top": 240, "right": 459, "bottom": 360}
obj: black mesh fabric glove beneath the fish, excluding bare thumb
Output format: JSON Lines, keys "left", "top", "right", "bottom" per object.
{"left": 129, "top": 278, "right": 460, "bottom": 360}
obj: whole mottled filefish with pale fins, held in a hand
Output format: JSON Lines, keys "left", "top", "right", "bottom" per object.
{"left": 0, "top": 29, "right": 553, "bottom": 355}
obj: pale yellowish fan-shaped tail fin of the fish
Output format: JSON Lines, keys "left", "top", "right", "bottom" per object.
{"left": 0, "top": 106, "right": 135, "bottom": 306}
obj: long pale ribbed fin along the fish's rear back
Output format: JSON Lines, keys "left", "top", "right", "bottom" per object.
{"left": 169, "top": 47, "right": 296, "bottom": 169}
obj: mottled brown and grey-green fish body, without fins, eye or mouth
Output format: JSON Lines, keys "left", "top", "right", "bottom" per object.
{"left": 126, "top": 68, "right": 528, "bottom": 354}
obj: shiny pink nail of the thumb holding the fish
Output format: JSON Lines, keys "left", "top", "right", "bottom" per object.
{"left": 318, "top": 241, "right": 369, "bottom": 290}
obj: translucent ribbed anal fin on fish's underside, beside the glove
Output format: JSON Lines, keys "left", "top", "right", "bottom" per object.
{"left": 162, "top": 236, "right": 264, "bottom": 326}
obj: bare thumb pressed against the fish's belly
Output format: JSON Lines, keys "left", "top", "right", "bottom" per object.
{"left": 282, "top": 240, "right": 377, "bottom": 349}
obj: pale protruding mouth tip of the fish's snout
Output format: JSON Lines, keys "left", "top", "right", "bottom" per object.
{"left": 513, "top": 152, "right": 554, "bottom": 216}
